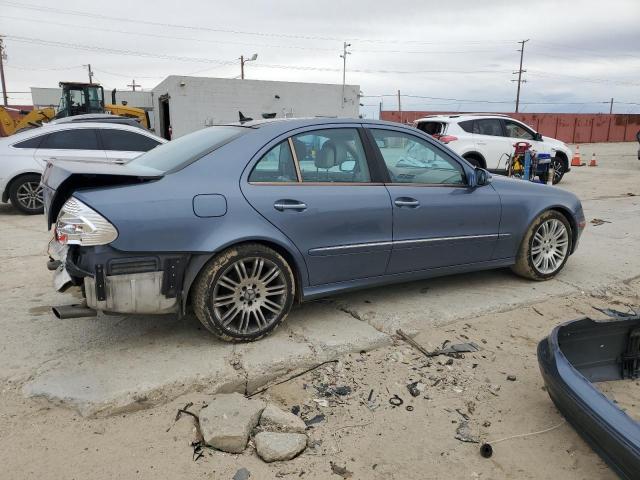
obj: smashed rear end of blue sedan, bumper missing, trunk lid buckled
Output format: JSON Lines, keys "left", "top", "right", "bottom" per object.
{"left": 42, "top": 162, "right": 185, "bottom": 317}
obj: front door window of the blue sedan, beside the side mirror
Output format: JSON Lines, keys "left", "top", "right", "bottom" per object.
{"left": 371, "top": 129, "right": 465, "bottom": 185}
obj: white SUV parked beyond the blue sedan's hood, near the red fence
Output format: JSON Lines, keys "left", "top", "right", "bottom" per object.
{"left": 413, "top": 114, "right": 572, "bottom": 183}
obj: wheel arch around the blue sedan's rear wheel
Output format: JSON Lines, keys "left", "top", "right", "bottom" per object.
{"left": 182, "top": 238, "right": 306, "bottom": 313}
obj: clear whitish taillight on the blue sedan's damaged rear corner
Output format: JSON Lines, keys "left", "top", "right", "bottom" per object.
{"left": 55, "top": 197, "right": 118, "bottom": 246}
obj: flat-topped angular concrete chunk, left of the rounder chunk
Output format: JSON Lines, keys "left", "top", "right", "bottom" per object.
{"left": 200, "top": 393, "right": 265, "bottom": 453}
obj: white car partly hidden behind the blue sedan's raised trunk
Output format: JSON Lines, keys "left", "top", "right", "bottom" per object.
{"left": 0, "top": 122, "right": 166, "bottom": 214}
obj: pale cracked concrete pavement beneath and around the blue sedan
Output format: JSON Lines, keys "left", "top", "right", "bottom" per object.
{"left": 0, "top": 143, "right": 640, "bottom": 476}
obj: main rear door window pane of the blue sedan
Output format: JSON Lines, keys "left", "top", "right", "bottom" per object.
{"left": 292, "top": 128, "right": 371, "bottom": 183}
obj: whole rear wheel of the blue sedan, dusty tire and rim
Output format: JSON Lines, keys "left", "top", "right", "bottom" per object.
{"left": 192, "top": 243, "right": 296, "bottom": 342}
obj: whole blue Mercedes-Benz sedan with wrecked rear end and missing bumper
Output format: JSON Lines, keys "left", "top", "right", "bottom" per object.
{"left": 43, "top": 118, "right": 585, "bottom": 340}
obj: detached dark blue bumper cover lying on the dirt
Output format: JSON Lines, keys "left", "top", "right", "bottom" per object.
{"left": 538, "top": 311, "right": 640, "bottom": 479}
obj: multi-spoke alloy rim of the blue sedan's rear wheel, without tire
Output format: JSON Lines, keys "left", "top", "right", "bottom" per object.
{"left": 213, "top": 257, "right": 287, "bottom": 335}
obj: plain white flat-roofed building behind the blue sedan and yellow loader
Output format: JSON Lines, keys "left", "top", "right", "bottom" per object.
{"left": 31, "top": 75, "right": 360, "bottom": 138}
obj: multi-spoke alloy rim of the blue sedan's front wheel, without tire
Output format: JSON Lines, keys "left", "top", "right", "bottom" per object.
{"left": 531, "top": 218, "right": 569, "bottom": 275}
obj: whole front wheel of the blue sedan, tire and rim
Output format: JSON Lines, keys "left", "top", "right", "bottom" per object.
{"left": 511, "top": 210, "right": 573, "bottom": 281}
